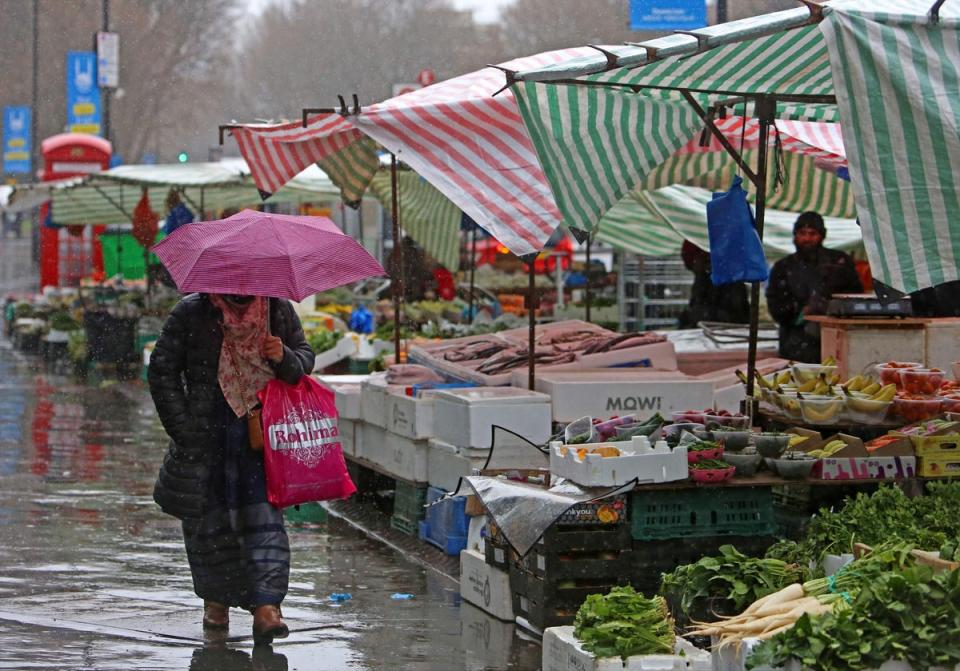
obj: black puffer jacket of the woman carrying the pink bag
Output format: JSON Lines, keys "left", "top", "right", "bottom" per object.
{"left": 147, "top": 294, "right": 314, "bottom": 519}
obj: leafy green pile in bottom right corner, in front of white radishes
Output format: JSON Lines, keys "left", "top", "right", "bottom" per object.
{"left": 747, "top": 566, "right": 960, "bottom": 671}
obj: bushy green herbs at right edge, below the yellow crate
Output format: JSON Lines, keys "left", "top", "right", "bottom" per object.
{"left": 802, "top": 482, "right": 960, "bottom": 561}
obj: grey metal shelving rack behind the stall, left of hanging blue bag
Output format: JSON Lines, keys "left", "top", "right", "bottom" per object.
{"left": 617, "top": 254, "right": 693, "bottom": 331}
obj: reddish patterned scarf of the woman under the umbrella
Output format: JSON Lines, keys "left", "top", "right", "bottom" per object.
{"left": 210, "top": 294, "right": 276, "bottom": 417}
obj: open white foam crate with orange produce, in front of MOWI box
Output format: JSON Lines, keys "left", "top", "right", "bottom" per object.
{"left": 550, "top": 436, "right": 689, "bottom": 487}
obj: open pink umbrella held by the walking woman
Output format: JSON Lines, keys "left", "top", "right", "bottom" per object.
{"left": 153, "top": 210, "right": 387, "bottom": 301}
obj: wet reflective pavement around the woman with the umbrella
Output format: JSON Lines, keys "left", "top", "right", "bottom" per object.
{"left": 0, "top": 338, "right": 540, "bottom": 671}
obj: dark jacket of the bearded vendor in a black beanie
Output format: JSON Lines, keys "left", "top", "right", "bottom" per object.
{"left": 767, "top": 247, "right": 863, "bottom": 363}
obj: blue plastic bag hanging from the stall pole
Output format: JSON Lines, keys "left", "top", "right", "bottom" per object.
{"left": 707, "top": 175, "right": 770, "bottom": 285}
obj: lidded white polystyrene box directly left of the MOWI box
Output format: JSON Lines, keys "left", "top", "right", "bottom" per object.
{"left": 433, "top": 387, "right": 551, "bottom": 448}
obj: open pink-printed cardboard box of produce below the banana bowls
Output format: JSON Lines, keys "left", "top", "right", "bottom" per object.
{"left": 794, "top": 433, "right": 917, "bottom": 480}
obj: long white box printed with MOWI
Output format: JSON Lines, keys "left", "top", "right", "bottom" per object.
{"left": 513, "top": 367, "right": 714, "bottom": 422}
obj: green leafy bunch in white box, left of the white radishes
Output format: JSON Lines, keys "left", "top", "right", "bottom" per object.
{"left": 573, "top": 586, "right": 676, "bottom": 659}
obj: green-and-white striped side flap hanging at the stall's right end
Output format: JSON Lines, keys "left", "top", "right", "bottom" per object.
{"left": 821, "top": 0, "right": 960, "bottom": 292}
